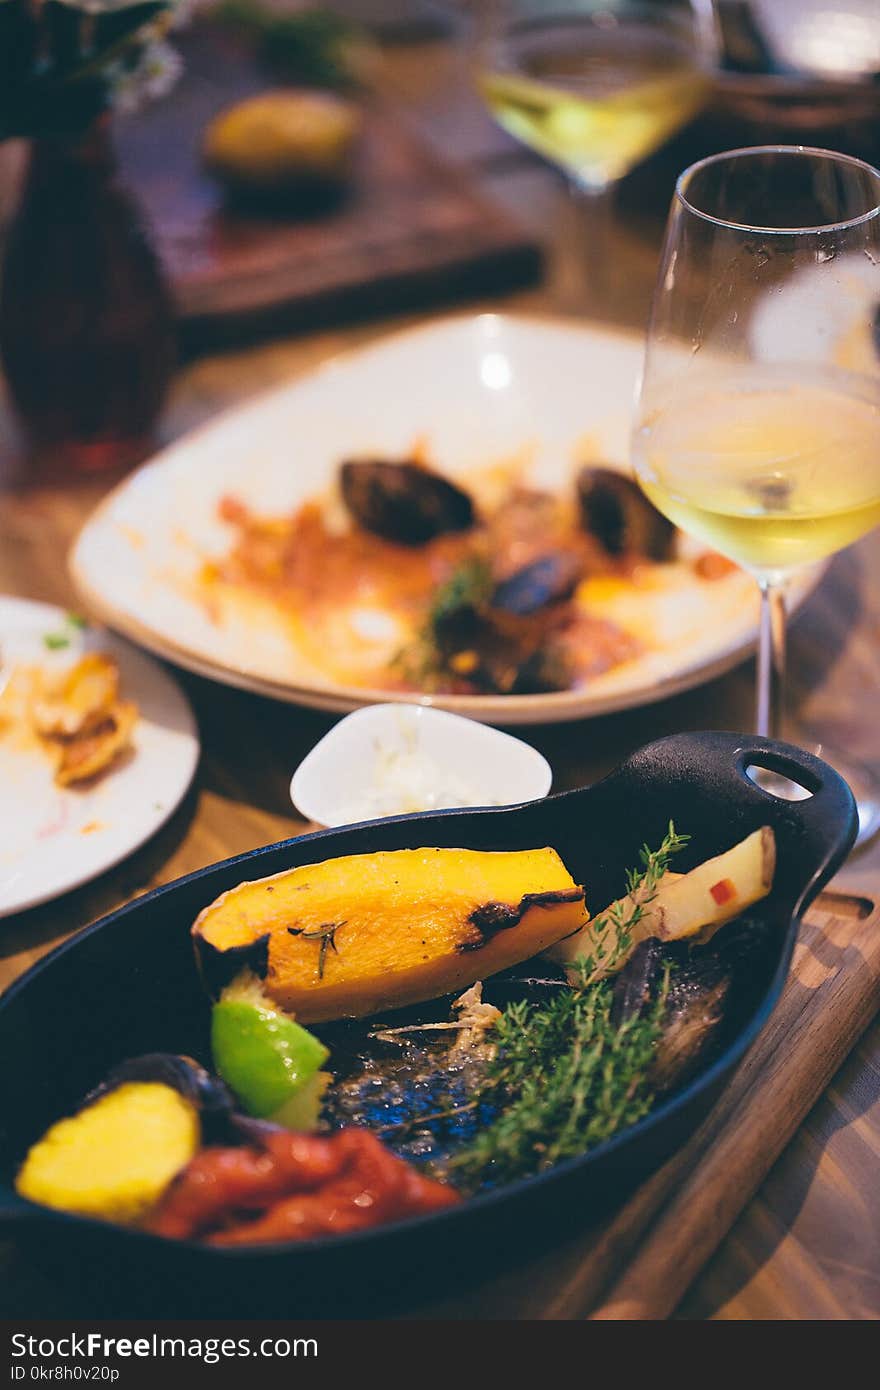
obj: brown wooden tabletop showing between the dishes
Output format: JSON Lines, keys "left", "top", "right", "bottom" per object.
{"left": 0, "top": 29, "right": 880, "bottom": 1319}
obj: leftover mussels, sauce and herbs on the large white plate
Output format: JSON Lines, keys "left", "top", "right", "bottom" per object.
{"left": 200, "top": 449, "right": 733, "bottom": 695}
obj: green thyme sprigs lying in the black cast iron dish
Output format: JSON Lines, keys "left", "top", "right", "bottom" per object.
{"left": 450, "top": 821, "right": 688, "bottom": 1187}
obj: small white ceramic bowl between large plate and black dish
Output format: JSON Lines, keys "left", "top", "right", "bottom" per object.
{"left": 291, "top": 705, "right": 553, "bottom": 826}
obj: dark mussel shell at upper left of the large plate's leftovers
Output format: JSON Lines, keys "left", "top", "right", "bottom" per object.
{"left": 339, "top": 459, "right": 474, "bottom": 545}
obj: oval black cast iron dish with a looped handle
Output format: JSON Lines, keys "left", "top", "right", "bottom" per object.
{"left": 0, "top": 734, "right": 856, "bottom": 1316}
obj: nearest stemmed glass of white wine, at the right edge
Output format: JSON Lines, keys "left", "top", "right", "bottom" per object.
{"left": 633, "top": 146, "right": 880, "bottom": 841}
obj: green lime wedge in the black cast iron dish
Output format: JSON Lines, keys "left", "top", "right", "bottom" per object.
{"left": 211, "top": 998, "right": 329, "bottom": 1119}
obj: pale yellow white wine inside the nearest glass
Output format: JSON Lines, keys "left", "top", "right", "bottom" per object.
{"left": 637, "top": 366, "right": 880, "bottom": 574}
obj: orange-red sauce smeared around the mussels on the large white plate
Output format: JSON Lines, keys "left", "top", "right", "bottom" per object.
{"left": 204, "top": 488, "right": 639, "bottom": 694}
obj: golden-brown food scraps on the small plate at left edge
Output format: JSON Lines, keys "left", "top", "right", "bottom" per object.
{"left": 0, "top": 636, "right": 138, "bottom": 787}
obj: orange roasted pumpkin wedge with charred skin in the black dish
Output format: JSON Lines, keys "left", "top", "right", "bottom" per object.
{"left": 193, "top": 849, "right": 585, "bottom": 1023}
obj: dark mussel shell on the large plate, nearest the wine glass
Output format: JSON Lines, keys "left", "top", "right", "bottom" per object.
{"left": 577, "top": 467, "right": 676, "bottom": 560}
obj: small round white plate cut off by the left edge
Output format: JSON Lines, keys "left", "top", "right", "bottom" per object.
{"left": 0, "top": 596, "right": 199, "bottom": 917}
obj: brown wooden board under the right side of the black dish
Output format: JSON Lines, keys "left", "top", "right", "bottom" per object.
{"left": 417, "top": 891, "right": 880, "bottom": 1319}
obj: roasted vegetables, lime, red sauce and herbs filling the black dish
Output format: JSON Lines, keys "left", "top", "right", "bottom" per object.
{"left": 17, "top": 824, "right": 776, "bottom": 1245}
